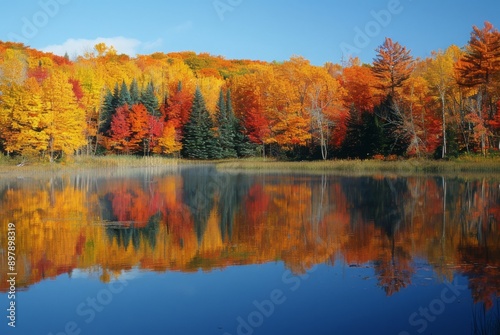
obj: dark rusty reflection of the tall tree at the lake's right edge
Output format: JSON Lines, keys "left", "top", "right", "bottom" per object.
{"left": 448, "top": 178, "right": 500, "bottom": 309}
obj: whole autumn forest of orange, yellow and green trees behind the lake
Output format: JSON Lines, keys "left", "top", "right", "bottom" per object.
{"left": 0, "top": 22, "right": 500, "bottom": 161}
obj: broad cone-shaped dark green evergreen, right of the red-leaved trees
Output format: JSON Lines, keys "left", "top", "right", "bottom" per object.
{"left": 181, "top": 88, "right": 220, "bottom": 159}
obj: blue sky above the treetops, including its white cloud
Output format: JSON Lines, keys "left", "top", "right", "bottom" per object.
{"left": 0, "top": 0, "right": 500, "bottom": 65}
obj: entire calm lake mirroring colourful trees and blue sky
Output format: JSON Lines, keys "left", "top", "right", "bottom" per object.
{"left": 0, "top": 165, "right": 500, "bottom": 335}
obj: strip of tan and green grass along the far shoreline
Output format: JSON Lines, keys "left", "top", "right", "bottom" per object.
{"left": 0, "top": 156, "right": 500, "bottom": 177}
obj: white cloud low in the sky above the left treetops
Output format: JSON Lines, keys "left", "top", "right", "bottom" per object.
{"left": 42, "top": 36, "right": 163, "bottom": 57}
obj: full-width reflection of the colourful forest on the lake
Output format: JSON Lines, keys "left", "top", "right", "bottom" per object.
{"left": 0, "top": 167, "right": 500, "bottom": 309}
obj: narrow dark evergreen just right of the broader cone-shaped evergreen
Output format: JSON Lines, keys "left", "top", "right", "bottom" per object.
{"left": 217, "top": 89, "right": 237, "bottom": 158}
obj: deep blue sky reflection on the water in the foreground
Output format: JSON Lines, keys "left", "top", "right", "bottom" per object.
{"left": 0, "top": 262, "right": 473, "bottom": 335}
